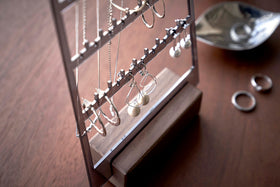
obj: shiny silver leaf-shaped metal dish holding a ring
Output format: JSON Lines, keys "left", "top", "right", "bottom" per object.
{"left": 196, "top": 2, "right": 280, "bottom": 51}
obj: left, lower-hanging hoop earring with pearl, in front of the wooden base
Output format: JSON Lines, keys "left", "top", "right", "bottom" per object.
{"left": 125, "top": 73, "right": 143, "bottom": 117}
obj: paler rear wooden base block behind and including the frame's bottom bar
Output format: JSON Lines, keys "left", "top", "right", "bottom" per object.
{"left": 89, "top": 68, "right": 180, "bottom": 175}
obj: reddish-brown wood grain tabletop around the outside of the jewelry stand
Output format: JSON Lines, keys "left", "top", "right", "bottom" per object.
{"left": 0, "top": 0, "right": 280, "bottom": 187}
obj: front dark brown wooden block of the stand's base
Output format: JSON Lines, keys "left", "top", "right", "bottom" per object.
{"left": 109, "top": 84, "right": 202, "bottom": 186}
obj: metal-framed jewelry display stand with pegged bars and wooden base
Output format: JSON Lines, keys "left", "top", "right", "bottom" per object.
{"left": 50, "top": 0, "right": 202, "bottom": 186}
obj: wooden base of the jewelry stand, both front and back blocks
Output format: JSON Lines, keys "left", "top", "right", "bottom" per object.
{"left": 90, "top": 70, "right": 202, "bottom": 186}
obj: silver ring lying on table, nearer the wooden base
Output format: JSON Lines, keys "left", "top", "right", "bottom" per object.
{"left": 231, "top": 90, "right": 257, "bottom": 112}
